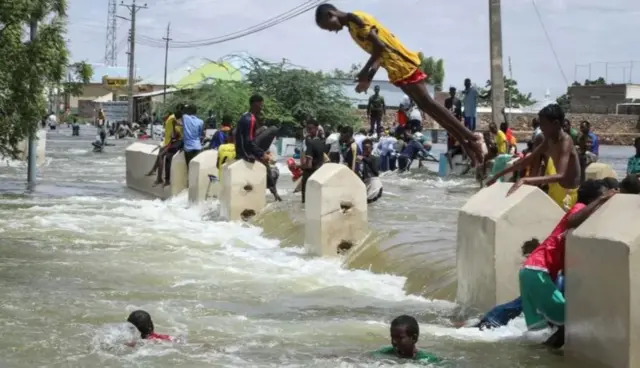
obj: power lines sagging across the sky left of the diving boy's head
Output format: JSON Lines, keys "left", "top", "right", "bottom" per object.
{"left": 135, "top": 0, "right": 328, "bottom": 48}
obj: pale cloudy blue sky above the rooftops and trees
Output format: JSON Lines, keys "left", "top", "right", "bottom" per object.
{"left": 68, "top": 0, "right": 640, "bottom": 99}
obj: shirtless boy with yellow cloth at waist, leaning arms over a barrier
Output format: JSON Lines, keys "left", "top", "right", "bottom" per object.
{"left": 487, "top": 104, "right": 580, "bottom": 204}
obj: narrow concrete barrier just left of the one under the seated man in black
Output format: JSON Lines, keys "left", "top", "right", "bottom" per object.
{"left": 189, "top": 150, "right": 220, "bottom": 202}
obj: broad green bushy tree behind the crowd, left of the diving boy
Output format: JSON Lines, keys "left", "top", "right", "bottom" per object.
{"left": 167, "top": 58, "right": 362, "bottom": 131}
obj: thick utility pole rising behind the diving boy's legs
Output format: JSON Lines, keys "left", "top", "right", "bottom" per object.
{"left": 489, "top": 0, "right": 504, "bottom": 124}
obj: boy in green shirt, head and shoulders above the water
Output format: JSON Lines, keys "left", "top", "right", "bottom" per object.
{"left": 373, "top": 315, "right": 442, "bottom": 363}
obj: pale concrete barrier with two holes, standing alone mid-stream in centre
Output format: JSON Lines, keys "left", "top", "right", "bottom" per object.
{"left": 304, "top": 163, "right": 367, "bottom": 257}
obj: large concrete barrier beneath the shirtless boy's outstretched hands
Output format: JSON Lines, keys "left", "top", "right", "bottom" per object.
{"left": 456, "top": 183, "right": 564, "bottom": 312}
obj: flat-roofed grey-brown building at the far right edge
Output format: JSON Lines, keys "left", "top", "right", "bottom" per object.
{"left": 569, "top": 84, "right": 640, "bottom": 115}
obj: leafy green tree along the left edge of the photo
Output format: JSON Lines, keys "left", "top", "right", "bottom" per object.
{"left": 0, "top": 0, "right": 88, "bottom": 157}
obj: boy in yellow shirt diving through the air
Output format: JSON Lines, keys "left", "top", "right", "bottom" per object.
{"left": 316, "top": 4, "right": 482, "bottom": 164}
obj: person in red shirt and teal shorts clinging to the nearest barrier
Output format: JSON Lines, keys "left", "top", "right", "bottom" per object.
{"left": 520, "top": 180, "right": 616, "bottom": 348}
